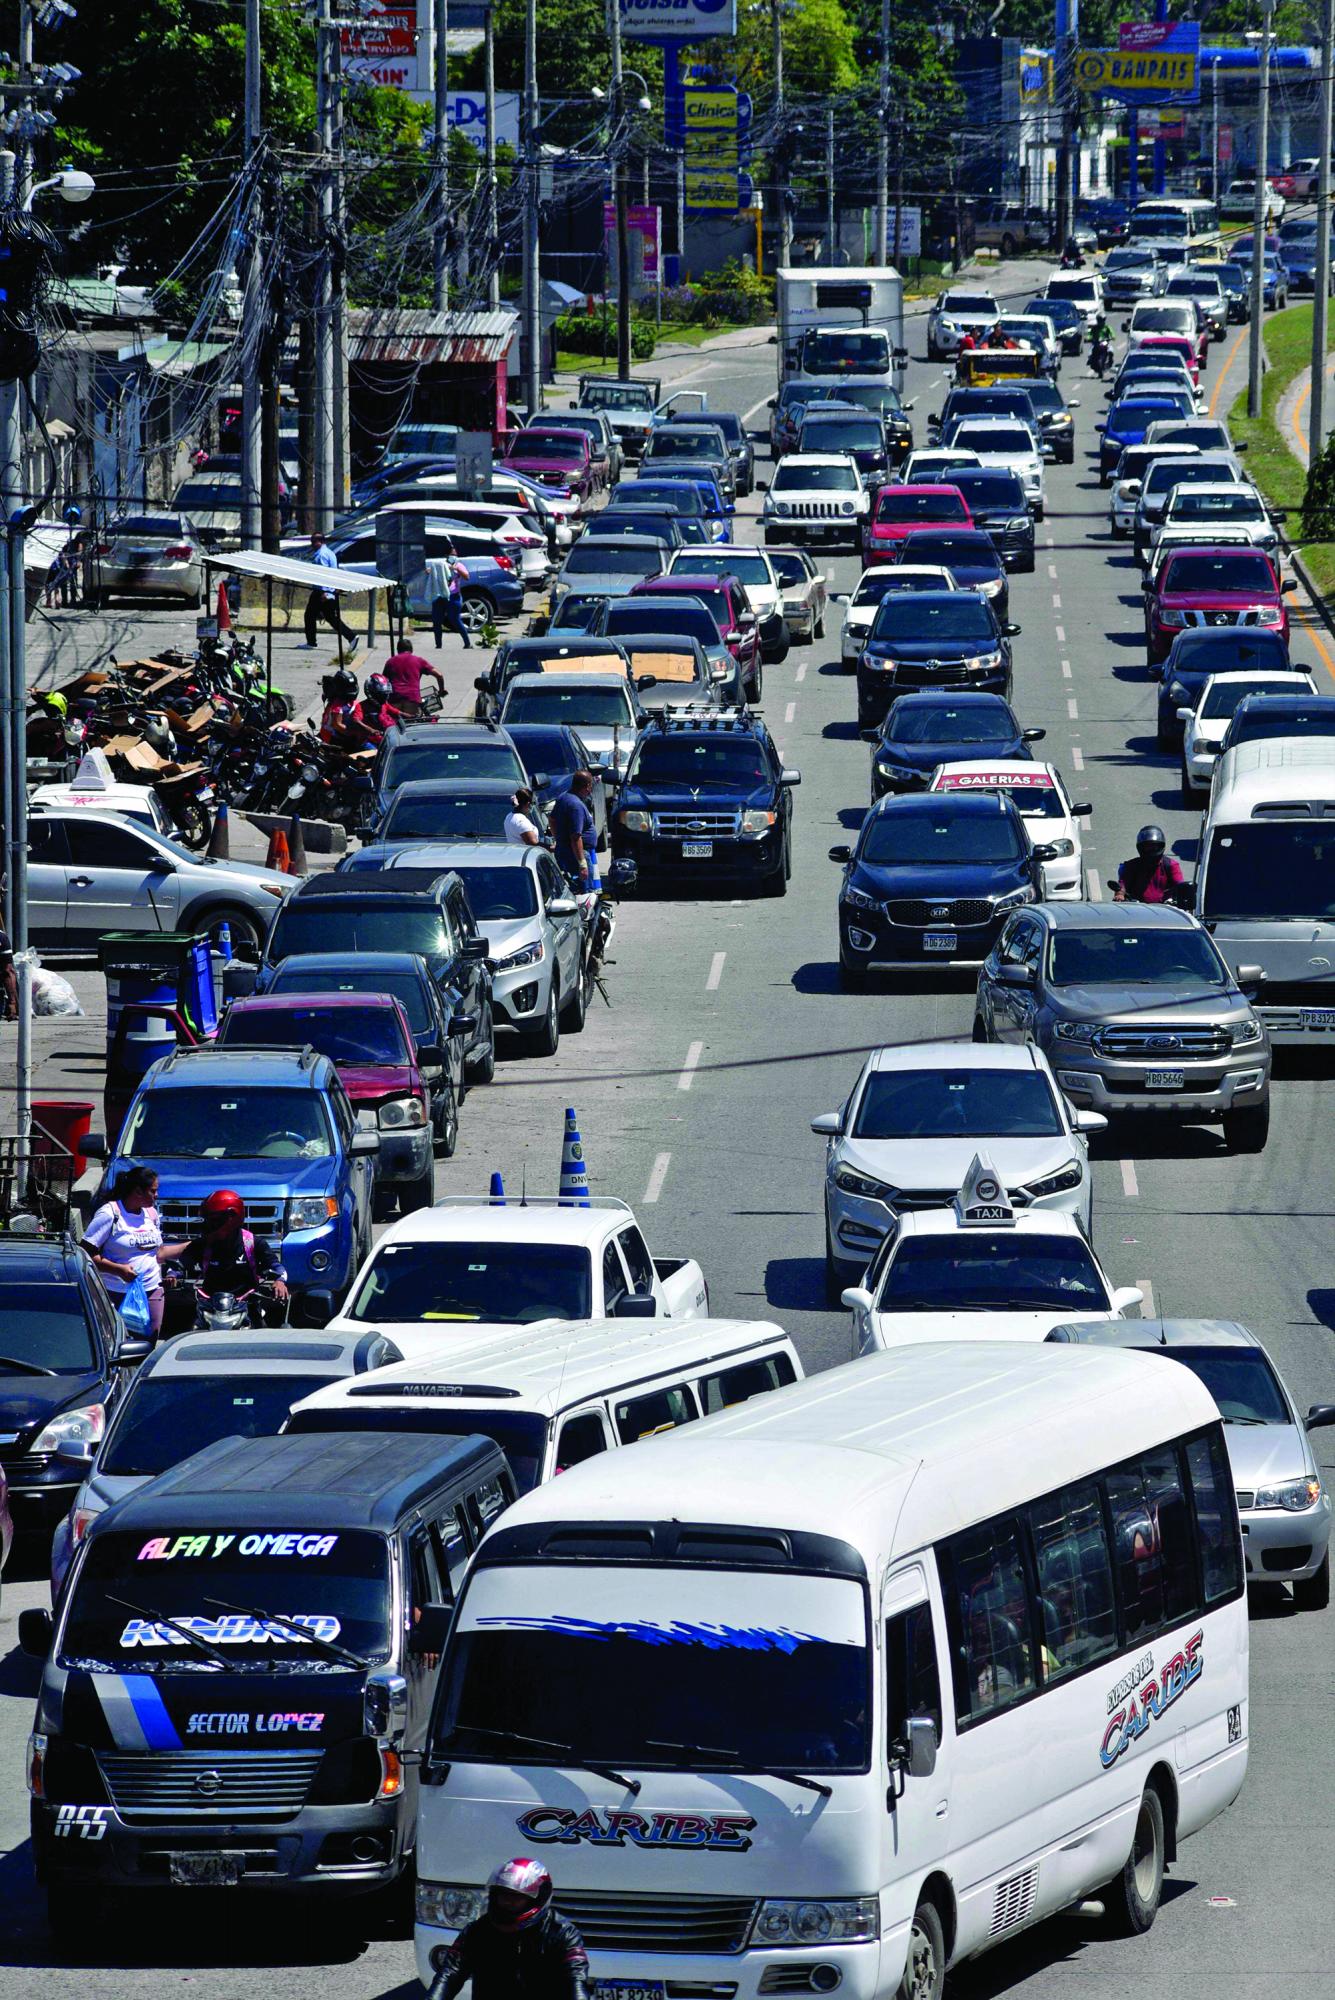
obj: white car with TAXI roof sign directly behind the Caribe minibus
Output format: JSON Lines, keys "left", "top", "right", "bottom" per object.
{"left": 843, "top": 1152, "right": 1143, "bottom": 1354}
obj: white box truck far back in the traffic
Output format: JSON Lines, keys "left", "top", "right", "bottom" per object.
{"left": 775, "top": 264, "right": 909, "bottom": 390}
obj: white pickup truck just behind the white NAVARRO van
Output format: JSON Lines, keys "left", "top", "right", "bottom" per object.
{"left": 330, "top": 1196, "right": 709, "bottom": 1360}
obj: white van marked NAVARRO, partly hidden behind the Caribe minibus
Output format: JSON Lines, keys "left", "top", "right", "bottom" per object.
{"left": 284, "top": 1320, "right": 801, "bottom": 1494}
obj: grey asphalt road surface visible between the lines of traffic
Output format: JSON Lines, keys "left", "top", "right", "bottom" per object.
{"left": 0, "top": 266, "right": 1335, "bottom": 2000}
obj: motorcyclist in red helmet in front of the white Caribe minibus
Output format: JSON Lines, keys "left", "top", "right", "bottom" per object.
{"left": 428, "top": 1856, "right": 590, "bottom": 2000}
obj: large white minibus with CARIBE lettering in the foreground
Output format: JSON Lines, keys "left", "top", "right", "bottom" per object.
{"left": 416, "top": 1336, "right": 1247, "bottom": 2000}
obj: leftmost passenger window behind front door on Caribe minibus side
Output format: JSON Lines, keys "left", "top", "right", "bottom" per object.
{"left": 943, "top": 1518, "right": 1035, "bottom": 1722}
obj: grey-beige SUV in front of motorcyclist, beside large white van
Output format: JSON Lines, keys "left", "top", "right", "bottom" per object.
{"left": 973, "top": 902, "right": 1271, "bottom": 1152}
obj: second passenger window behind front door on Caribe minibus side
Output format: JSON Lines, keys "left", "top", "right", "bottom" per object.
{"left": 1029, "top": 1480, "right": 1117, "bottom": 1686}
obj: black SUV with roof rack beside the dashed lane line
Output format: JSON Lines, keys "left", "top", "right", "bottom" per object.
{"left": 612, "top": 708, "right": 801, "bottom": 896}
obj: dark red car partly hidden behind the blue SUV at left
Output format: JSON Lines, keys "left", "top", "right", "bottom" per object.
{"left": 218, "top": 992, "right": 445, "bottom": 1214}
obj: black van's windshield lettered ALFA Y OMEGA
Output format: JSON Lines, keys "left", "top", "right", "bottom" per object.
{"left": 56, "top": 1528, "right": 392, "bottom": 1678}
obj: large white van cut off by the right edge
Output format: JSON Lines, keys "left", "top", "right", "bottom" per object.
{"left": 1195, "top": 736, "right": 1335, "bottom": 1048}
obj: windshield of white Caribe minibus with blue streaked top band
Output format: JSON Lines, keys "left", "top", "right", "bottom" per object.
{"left": 432, "top": 1568, "right": 871, "bottom": 1776}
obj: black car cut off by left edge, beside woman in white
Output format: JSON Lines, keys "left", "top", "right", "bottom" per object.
{"left": 0, "top": 1236, "right": 131, "bottom": 1532}
